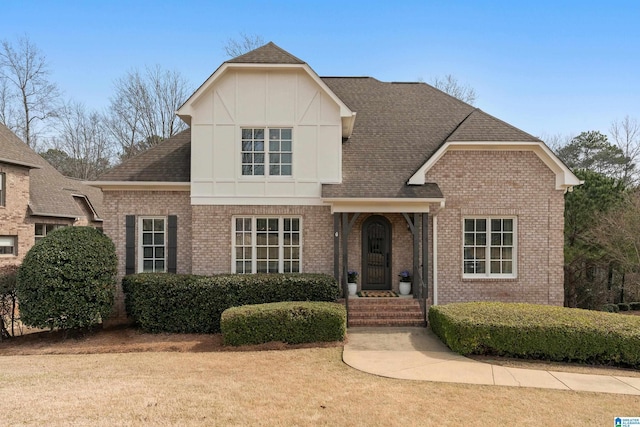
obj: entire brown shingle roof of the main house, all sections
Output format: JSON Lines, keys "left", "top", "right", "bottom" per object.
{"left": 100, "top": 42, "right": 539, "bottom": 198}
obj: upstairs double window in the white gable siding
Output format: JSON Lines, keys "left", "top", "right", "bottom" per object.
{"left": 241, "top": 128, "right": 293, "bottom": 176}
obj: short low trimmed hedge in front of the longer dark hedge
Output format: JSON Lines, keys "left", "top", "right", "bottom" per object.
{"left": 220, "top": 302, "right": 347, "bottom": 346}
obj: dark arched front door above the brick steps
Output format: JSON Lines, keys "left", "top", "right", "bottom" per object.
{"left": 362, "top": 215, "right": 391, "bottom": 290}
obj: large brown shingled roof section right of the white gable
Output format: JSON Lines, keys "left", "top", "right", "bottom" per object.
{"left": 322, "top": 77, "right": 538, "bottom": 198}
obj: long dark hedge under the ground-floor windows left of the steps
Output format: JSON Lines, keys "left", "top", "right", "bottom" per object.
{"left": 122, "top": 273, "right": 340, "bottom": 333}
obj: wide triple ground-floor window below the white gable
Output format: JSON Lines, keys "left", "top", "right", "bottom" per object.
{"left": 232, "top": 217, "right": 302, "bottom": 273}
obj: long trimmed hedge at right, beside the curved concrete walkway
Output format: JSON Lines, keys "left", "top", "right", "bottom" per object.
{"left": 429, "top": 303, "right": 640, "bottom": 368}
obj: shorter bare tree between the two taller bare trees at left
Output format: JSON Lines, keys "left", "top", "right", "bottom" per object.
{"left": 42, "top": 103, "right": 114, "bottom": 180}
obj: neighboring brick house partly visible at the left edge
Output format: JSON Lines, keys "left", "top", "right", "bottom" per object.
{"left": 0, "top": 124, "right": 102, "bottom": 266}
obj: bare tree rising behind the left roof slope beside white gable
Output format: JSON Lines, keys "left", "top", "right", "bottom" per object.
{"left": 105, "top": 65, "right": 189, "bottom": 159}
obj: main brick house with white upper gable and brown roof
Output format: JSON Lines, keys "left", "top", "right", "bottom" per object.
{"left": 92, "top": 43, "right": 579, "bottom": 322}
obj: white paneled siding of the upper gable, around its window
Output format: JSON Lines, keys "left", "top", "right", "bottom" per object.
{"left": 190, "top": 68, "right": 342, "bottom": 205}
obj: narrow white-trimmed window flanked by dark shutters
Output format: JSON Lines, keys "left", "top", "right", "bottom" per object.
{"left": 138, "top": 217, "right": 167, "bottom": 273}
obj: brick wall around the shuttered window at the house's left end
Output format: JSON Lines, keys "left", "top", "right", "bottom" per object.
{"left": 103, "top": 191, "right": 192, "bottom": 323}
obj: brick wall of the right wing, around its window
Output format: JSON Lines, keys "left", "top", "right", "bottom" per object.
{"left": 427, "top": 151, "right": 564, "bottom": 305}
